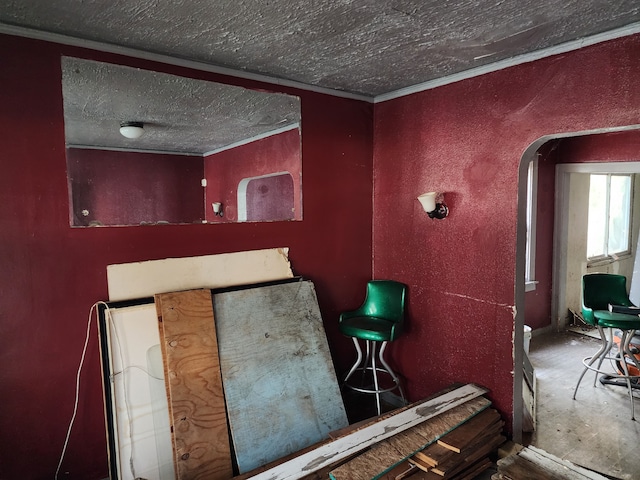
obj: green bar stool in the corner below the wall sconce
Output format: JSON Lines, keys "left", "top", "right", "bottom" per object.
{"left": 339, "top": 280, "right": 407, "bottom": 415}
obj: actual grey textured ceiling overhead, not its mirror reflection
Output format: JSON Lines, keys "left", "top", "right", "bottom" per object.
{"left": 0, "top": 0, "right": 640, "bottom": 97}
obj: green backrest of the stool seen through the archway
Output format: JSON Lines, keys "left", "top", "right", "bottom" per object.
{"left": 582, "top": 273, "right": 633, "bottom": 325}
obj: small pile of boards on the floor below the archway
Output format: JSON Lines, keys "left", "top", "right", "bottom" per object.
{"left": 491, "top": 446, "right": 606, "bottom": 480}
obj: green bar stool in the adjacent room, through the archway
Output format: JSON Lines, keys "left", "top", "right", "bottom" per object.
{"left": 573, "top": 273, "right": 640, "bottom": 419}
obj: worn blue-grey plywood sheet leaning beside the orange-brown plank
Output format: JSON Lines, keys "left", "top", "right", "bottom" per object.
{"left": 213, "top": 281, "right": 348, "bottom": 473}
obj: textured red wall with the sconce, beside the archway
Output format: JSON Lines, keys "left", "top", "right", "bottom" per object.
{"left": 373, "top": 36, "right": 640, "bottom": 428}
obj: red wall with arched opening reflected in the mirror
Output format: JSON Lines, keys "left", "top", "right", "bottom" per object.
{"left": 204, "top": 128, "right": 306, "bottom": 222}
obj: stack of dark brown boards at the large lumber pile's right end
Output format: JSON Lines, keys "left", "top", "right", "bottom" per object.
{"left": 405, "top": 408, "right": 506, "bottom": 480}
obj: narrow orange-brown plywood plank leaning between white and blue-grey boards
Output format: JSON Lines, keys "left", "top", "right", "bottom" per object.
{"left": 155, "top": 290, "right": 233, "bottom": 480}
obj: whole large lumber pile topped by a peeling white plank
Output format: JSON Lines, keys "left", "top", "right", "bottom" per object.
{"left": 236, "top": 384, "right": 504, "bottom": 480}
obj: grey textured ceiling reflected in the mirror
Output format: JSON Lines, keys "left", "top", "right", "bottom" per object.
{"left": 62, "top": 57, "right": 300, "bottom": 155}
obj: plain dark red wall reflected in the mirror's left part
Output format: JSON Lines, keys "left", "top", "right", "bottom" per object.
{"left": 67, "top": 148, "right": 204, "bottom": 226}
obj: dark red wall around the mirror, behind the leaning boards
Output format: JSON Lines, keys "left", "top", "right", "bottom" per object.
{"left": 0, "top": 36, "right": 373, "bottom": 480}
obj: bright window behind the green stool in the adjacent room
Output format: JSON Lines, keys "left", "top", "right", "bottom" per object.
{"left": 587, "top": 174, "right": 632, "bottom": 262}
